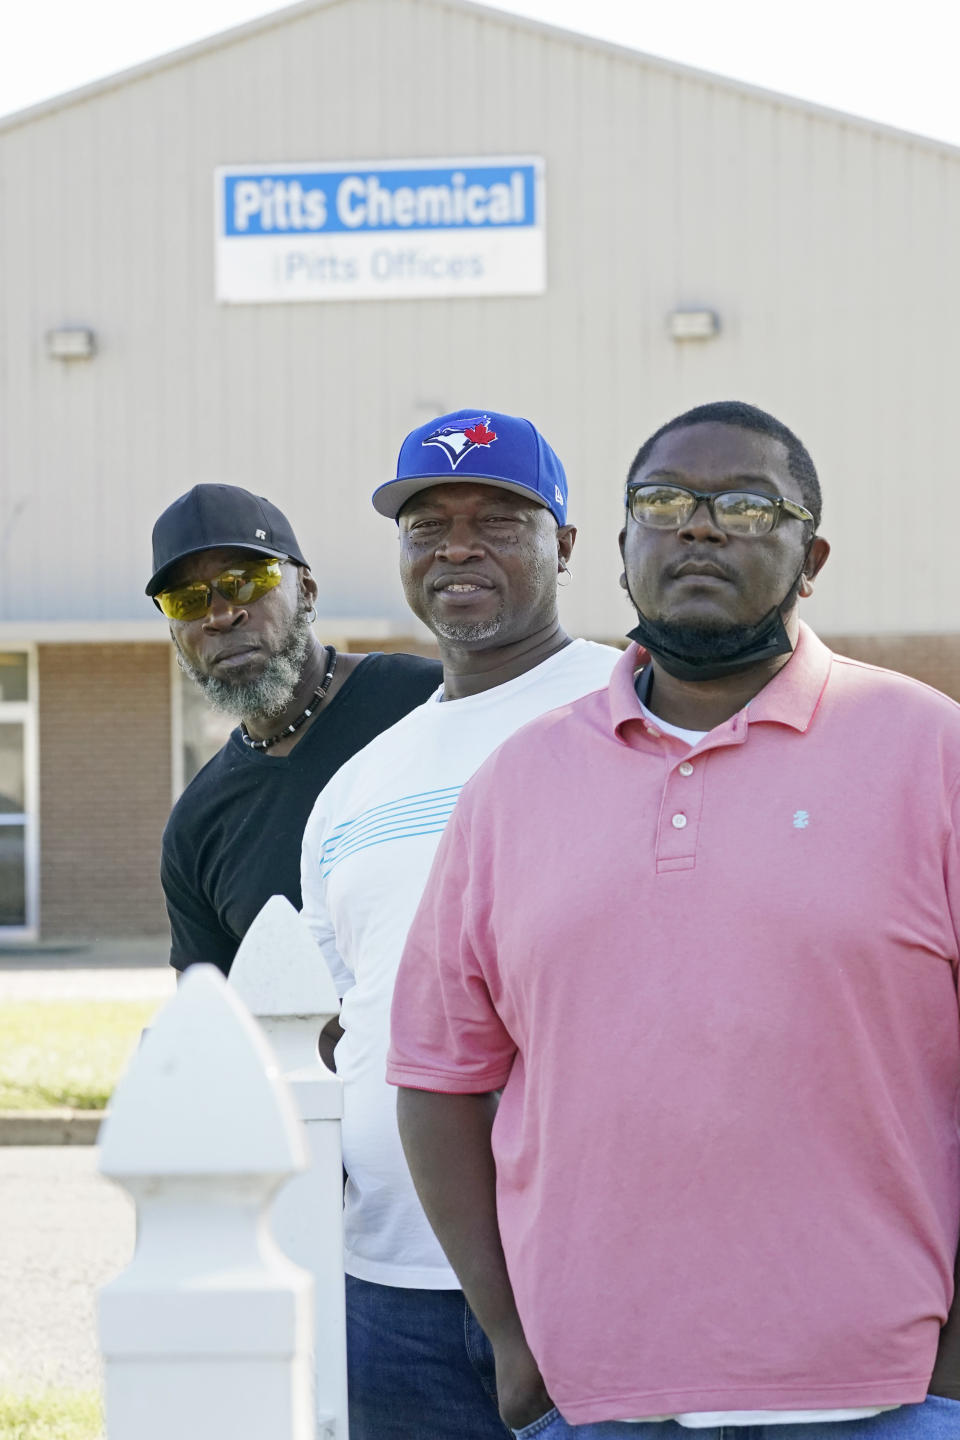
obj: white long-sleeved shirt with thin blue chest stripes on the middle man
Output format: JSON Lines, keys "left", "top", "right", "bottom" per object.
{"left": 301, "top": 639, "right": 620, "bottom": 1290}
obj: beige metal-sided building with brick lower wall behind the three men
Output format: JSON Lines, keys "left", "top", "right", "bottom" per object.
{"left": 0, "top": 0, "right": 960, "bottom": 939}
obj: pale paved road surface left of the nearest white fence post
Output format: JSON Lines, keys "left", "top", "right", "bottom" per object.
{"left": 0, "top": 1146, "right": 134, "bottom": 1388}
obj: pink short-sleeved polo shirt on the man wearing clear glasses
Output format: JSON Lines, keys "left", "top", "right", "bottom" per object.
{"left": 389, "top": 628, "right": 960, "bottom": 1424}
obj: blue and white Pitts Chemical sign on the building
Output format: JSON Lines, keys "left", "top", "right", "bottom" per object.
{"left": 216, "top": 156, "right": 547, "bottom": 302}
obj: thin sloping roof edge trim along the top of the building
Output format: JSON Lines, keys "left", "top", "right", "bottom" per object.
{"left": 0, "top": 0, "right": 960, "bottom": 158}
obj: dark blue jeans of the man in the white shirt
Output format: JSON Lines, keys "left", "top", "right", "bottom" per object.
{"left": 347, "top": 1274, "right": 509, "bottom": 1440}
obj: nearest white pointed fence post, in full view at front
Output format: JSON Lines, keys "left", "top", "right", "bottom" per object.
{"left": 99, "top": 965, "right": 314, "bottom": 1440}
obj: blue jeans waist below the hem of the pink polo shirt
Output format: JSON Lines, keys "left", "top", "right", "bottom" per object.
{"left": 514, "top": 1395, "right": 960, "bottom": 1440}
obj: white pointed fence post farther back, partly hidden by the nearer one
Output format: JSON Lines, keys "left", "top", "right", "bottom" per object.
{"left": 230, "top": 896, "right": 348, "bottom": 1440}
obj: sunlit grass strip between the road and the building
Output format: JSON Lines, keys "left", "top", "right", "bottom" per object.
{"left": 0, "top": 1001, "right": 161, "bottom": 1111}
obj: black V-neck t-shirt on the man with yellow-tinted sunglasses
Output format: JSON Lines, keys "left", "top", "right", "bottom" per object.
{"left": 160, "top": 654, "right": 443, "bottom": 975}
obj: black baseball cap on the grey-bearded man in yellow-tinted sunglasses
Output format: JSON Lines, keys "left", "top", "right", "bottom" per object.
{"left": 145, "top": 485, "right": 307, "bottom": 596}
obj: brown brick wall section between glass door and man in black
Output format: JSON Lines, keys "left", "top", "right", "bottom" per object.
{"left": 37, "top": 645, "right": 171, "bottom": 939}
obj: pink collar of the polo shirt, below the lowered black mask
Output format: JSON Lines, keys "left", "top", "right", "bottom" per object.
{"left": 609, "top": 621, "right": 833, "bottom": 739}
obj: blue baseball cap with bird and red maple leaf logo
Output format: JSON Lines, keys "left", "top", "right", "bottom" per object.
{"left": 373, "top": 410, "right": 567, "bottom": 526}
